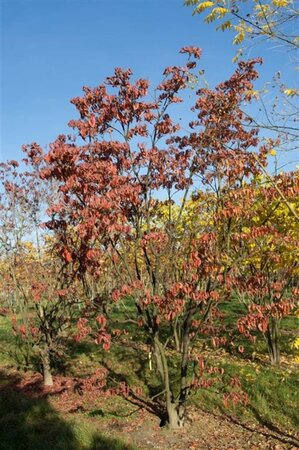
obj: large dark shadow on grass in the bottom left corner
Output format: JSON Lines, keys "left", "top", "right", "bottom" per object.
{"left": 0, "top": 371, "right": 133, "bottom": 450}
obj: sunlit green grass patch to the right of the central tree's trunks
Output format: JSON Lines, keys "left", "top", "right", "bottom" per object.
{"left": 194, "top": 358, "right": 299, "bottom": 434}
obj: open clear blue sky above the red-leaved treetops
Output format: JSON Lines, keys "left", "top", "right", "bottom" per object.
{"left": 0, "top": 0, "right": 298, "bottom": 167}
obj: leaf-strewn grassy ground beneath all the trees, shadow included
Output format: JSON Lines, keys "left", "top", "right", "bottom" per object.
{"left": 0, "top": 310, "right": 299, "bottom": 450}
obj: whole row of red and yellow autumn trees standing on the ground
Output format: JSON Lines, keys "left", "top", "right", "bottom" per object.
{"left": 0, "top": 47, "right": 299, "bottom": 427}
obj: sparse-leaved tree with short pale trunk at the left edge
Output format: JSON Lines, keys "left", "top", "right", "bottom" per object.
{"left": 0, "top": 155, "right": 77, "bottom": 386}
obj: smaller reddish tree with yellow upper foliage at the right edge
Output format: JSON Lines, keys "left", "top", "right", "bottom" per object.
{"left": 233, "top": 172, "right": 299, "bottom": 365}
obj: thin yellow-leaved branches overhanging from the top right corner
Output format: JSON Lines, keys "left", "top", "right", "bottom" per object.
{"left": 185, "top": 0, "right": 299, "bottom": 171}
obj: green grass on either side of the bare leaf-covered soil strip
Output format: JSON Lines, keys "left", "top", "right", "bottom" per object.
{"left": 0, "top": 294, "right": 299, "bottom": 450}
